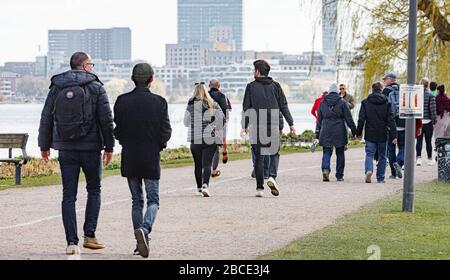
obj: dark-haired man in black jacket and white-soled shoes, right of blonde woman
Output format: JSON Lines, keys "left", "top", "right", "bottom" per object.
{"left": 242, "top": 60, "right": 296, "bottom": 197}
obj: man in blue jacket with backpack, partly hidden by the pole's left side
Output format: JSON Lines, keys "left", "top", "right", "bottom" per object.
{"left": 383, "top": 72, "right": 406, "bottom": 179}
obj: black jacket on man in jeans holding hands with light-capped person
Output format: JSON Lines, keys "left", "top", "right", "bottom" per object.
{"left": 356, "top": 93, "right": 397, "bottom": 143}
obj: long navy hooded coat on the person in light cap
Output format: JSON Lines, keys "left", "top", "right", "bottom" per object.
{"left": 316, "top": 92, "right": 356, "bottom": 148}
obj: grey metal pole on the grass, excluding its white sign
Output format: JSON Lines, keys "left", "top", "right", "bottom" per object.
{"left": 403, "top": 0, "right": 417, "bottom": 213}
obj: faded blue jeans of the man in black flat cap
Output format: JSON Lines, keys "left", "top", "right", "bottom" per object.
{"left": 127, "top": 178, "right": 159, "bottom": 234}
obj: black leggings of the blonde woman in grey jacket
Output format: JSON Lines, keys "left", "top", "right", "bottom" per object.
{"left": 191, "top": 144, "right": 217, "bottom": 189}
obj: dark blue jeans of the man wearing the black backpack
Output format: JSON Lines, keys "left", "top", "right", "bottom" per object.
{"left": 58, "top": 151, "right": 102, "bottom": 244}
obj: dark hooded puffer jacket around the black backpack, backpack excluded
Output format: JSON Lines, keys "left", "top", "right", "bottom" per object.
{"left": 38, "top": 70, "right": 114, "bottom": 152}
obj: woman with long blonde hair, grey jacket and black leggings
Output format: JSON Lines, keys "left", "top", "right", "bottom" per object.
{"left": 184, "top": 83, "right": 225, "bottom": 197}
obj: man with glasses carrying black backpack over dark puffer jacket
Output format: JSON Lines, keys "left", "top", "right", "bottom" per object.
{"left": 38, "top": 52, "right": 114, "bottom": 255}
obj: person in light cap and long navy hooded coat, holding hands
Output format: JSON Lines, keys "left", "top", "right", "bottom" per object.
{"left": 316, "top": 84, "right": 356, "bottom": 182}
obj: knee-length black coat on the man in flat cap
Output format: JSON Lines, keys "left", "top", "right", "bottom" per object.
{"left": 114, "top": 87, "right": 172, "bottom": 180}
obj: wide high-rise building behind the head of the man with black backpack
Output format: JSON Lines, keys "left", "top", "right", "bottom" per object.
{"left": 47, "top": 28, "right": 131, "bottom": 74}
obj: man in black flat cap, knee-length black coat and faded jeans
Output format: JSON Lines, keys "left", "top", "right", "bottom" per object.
{"left": 114, "top": 63, "right": 172, "bottom": 258}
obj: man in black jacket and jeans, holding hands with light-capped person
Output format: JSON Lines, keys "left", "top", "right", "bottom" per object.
{"left": 356, "top": 83, "right": 397, "bottom": 184}
